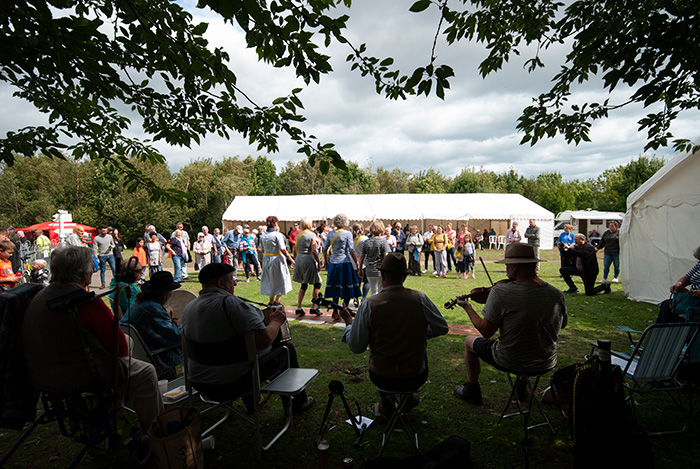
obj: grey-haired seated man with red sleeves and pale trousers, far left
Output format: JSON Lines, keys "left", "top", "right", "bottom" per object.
{"left": 22, "top": 246, "right": 163, "bottom": 432}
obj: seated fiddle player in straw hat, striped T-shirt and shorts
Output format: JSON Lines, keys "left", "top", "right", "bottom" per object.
{"left": 454, "top": 243, "right": 567, "bottom": 405}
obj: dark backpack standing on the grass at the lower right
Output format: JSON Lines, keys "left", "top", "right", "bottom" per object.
{"left": 568, "top": 355, "right": 654, "bottom": 468}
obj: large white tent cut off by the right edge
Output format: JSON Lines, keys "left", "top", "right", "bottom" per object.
{"left": 620, "top": 142, "right": 700, "bottom": 303}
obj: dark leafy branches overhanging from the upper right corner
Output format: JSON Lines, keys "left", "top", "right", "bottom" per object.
{"left": 378, "top": 0, "right": 700, "bottom": 151}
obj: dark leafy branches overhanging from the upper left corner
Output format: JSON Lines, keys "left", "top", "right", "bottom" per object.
{"left": 0, "top": 0, "right": 347, "bottom": 197}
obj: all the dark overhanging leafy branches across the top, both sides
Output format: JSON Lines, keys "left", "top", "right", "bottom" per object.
{"left": 0, "top": 0, "right": 700, "bottom": 194}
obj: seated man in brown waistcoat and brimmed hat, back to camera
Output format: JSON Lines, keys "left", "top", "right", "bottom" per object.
{"left": 340, "top": 253, "right": 448, "bottom": 416}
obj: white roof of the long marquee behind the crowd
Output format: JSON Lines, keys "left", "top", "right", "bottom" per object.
{"left": 222, "top": 194, "right": 554, "bottom": 249}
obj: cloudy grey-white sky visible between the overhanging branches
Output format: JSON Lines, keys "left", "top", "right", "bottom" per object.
{"left": 0, "top": 0, "right": 699, "bottom": 180}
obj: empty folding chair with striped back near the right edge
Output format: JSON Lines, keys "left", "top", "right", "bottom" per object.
{"left": 612, "top": 322, "right": 698, "bottom": 435}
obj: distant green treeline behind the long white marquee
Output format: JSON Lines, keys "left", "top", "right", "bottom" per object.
{"left": 0, "top": 156, "right": 664, "bottom": 246}
